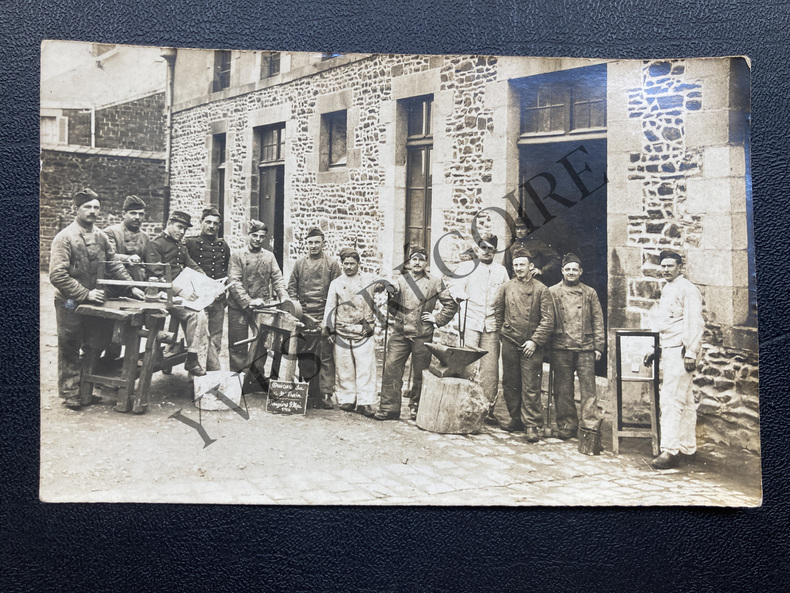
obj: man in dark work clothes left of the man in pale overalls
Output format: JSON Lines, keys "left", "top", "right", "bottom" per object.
{"left": 288, "top": 228, "right": 341, "bottom": 410}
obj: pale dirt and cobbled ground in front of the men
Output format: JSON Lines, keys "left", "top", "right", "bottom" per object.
{"left": 40, "top": 275, "right": 760, "bottom": 506}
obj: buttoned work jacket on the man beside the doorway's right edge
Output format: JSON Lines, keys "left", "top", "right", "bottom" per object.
{"left": 549, "top": 282, "right": 606, "bottom": 352}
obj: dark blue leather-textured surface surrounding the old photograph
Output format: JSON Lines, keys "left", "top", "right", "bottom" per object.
{"left": 0, "top": 0, "right": 790, "bottom": 592}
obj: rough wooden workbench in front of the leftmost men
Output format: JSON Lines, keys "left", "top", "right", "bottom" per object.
{"left": 77, "top": 299, "right": 186, "bottom": 414}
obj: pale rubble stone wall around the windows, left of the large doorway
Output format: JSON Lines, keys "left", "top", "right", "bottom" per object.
{"left": 171, "top": 55, "right": 504, "bottom": 271}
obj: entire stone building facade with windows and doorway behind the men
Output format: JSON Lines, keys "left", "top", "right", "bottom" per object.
{"left": 167, "top": 50, "right": 759, "bottom": 450}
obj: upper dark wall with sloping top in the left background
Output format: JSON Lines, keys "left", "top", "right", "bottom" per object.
{"left": 96, "top": 92, "right": 165, "bottom": 151}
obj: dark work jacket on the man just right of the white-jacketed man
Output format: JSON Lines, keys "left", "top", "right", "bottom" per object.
{"left": 494, "top": 278, "right": 554, "bottom": 346}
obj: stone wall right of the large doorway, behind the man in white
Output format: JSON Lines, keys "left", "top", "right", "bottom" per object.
{"left": 609, "top": 60, "right": 760, "bottom": 451}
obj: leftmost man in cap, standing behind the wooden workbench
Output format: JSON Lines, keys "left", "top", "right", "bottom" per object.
{"left": 49, "top": 188, "right": 144, "bottom": 408}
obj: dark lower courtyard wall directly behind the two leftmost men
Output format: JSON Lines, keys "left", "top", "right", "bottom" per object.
{"left": 39, "top": 147, "right": 165, "bottom": 270}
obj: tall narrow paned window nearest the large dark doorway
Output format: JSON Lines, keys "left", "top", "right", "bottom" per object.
{"left": 404, "top": 95, "right": 433, "bottom": 252}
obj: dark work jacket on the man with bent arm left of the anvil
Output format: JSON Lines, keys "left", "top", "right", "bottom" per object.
{"left": 390, "top": 273, "right": 458, "bottom": 338}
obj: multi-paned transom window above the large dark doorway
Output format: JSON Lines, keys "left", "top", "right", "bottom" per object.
{"left": 514, "top": 65, "right": 606, "bottom": 137}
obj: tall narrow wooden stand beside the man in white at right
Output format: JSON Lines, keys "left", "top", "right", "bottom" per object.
{"left": 612, "top": 329, "right": 661, "bottom": 455}
